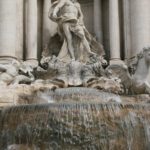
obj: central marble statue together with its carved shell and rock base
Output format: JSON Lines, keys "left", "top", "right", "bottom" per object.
{"left": 37, "top": 0, "right": 121, "bottom": 93}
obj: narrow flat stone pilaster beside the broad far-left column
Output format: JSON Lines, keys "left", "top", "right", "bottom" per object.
{"left": 16, "top": 0, "right": 24, "bottom": 60}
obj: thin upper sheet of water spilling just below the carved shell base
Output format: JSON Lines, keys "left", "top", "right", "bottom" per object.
{"left": 34, "top": 87, "right": 121, "bottom": 103}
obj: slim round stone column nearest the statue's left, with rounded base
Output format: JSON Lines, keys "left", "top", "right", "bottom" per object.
{"left": 26, "top": 0, "right": 38, "bottom": 65}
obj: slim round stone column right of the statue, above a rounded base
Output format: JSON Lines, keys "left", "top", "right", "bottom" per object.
{"left": 109, "top": 0, "right": 120, "bottom": 63}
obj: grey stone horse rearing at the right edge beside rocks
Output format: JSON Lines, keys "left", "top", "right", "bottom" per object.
{"left": 106, "top": 48, "right": 150, "bottom": 94}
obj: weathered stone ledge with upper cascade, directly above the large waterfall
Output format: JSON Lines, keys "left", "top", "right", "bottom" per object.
{"left": 0, "top": 83, "right": 150, "bottom": 107}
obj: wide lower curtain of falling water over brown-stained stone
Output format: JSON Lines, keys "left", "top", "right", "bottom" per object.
{"left": 0, "top": 102, "right": 150, "bottom": 150}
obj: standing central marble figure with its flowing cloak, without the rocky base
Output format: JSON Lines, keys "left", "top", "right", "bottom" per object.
{"left": 49, "top": 0, "right": 104, "bottom": 60}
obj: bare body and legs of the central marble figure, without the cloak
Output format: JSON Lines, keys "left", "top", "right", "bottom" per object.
{"left": 50, "top": 0, "right": 95, "bottom": 60}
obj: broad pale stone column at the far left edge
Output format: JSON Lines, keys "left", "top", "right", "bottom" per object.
{"left": 0, "top": 0, "right": 17, "bottom": 63}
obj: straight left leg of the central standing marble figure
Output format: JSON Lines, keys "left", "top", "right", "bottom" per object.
{"left": 63, "top": 23, "right": 75, "bottom": 60}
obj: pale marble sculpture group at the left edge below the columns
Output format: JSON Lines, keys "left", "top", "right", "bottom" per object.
{"left": 0, "top": 60, "right": 35, "bottom": 85}
